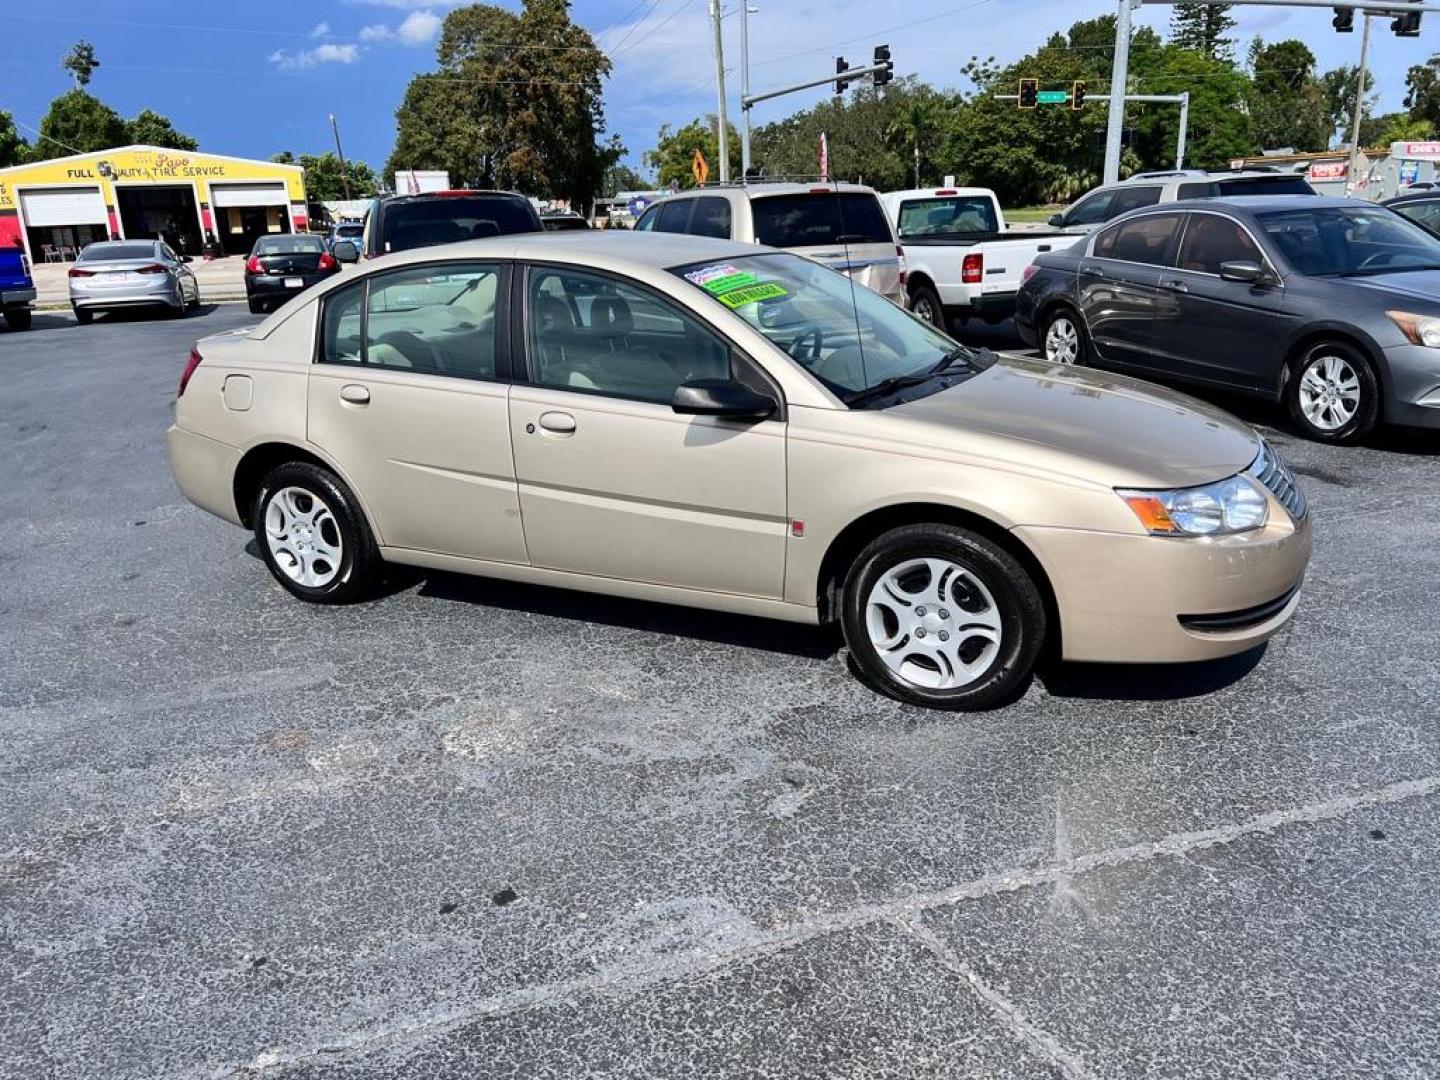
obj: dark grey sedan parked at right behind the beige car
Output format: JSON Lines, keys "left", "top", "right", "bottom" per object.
{"left": 1015, "top": 196, "right": 1440, "bottom": 442}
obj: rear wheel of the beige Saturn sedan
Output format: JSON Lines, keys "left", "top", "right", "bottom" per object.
{"left": 251, "top": 462, "right": 380, "bottom": 603}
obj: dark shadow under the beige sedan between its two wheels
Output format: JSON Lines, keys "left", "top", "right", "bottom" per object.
{"left": 417, "top": 570, "right": 841, "bottom": 660}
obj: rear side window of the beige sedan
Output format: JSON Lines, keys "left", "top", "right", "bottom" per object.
{"left": 321, "top": 262, "right": 503, "bottom": 379}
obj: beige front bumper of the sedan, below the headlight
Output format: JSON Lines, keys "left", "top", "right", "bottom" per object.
{"left": 1015, "top": 497, "right": 1312, "bottom": 664}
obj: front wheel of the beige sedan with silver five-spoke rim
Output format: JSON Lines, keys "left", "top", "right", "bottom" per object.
{"left": 841, "top": 524, "right": 1045, "bottom": 711}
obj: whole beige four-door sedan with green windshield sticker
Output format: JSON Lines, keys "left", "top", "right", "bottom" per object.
{"left": 168, "top": 233, "right": 1310, "bottom": 710}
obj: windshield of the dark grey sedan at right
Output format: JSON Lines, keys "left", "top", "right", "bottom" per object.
{"left": 1260, "top": 206, "right": 1440, "bottom": 278}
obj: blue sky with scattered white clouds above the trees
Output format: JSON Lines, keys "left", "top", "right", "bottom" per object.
{"left": 0, "top": 0, "right": 1440, "bottom": 180}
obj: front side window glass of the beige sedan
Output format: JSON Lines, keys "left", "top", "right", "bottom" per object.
{"left": 527, "top": 268, "right": 730, "bottom": 405}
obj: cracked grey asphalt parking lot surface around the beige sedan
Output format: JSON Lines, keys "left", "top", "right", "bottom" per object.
{"left": 0, "top": 305, "right": 1440, "bottom": 1080}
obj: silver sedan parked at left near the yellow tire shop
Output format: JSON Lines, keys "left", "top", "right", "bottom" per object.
{"left": 69, "top": 240, "right": 200, "bottom": 323}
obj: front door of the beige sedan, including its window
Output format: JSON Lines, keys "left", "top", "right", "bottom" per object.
{"left": 510, "top": 265, "right": 788, "bottom": 598}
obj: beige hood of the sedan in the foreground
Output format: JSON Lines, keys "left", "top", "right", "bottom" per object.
{"left": 886, "top": 357, "right": 1260, "bottom": 488}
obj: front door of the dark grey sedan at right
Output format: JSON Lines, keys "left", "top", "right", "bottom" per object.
{"left": 1153, "top": 210, "right": 1292, "bottom": 389}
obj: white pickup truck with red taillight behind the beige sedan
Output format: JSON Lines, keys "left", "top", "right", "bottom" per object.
{"left": 880, "top": 187, "right": 1076, "bottom": 330}
